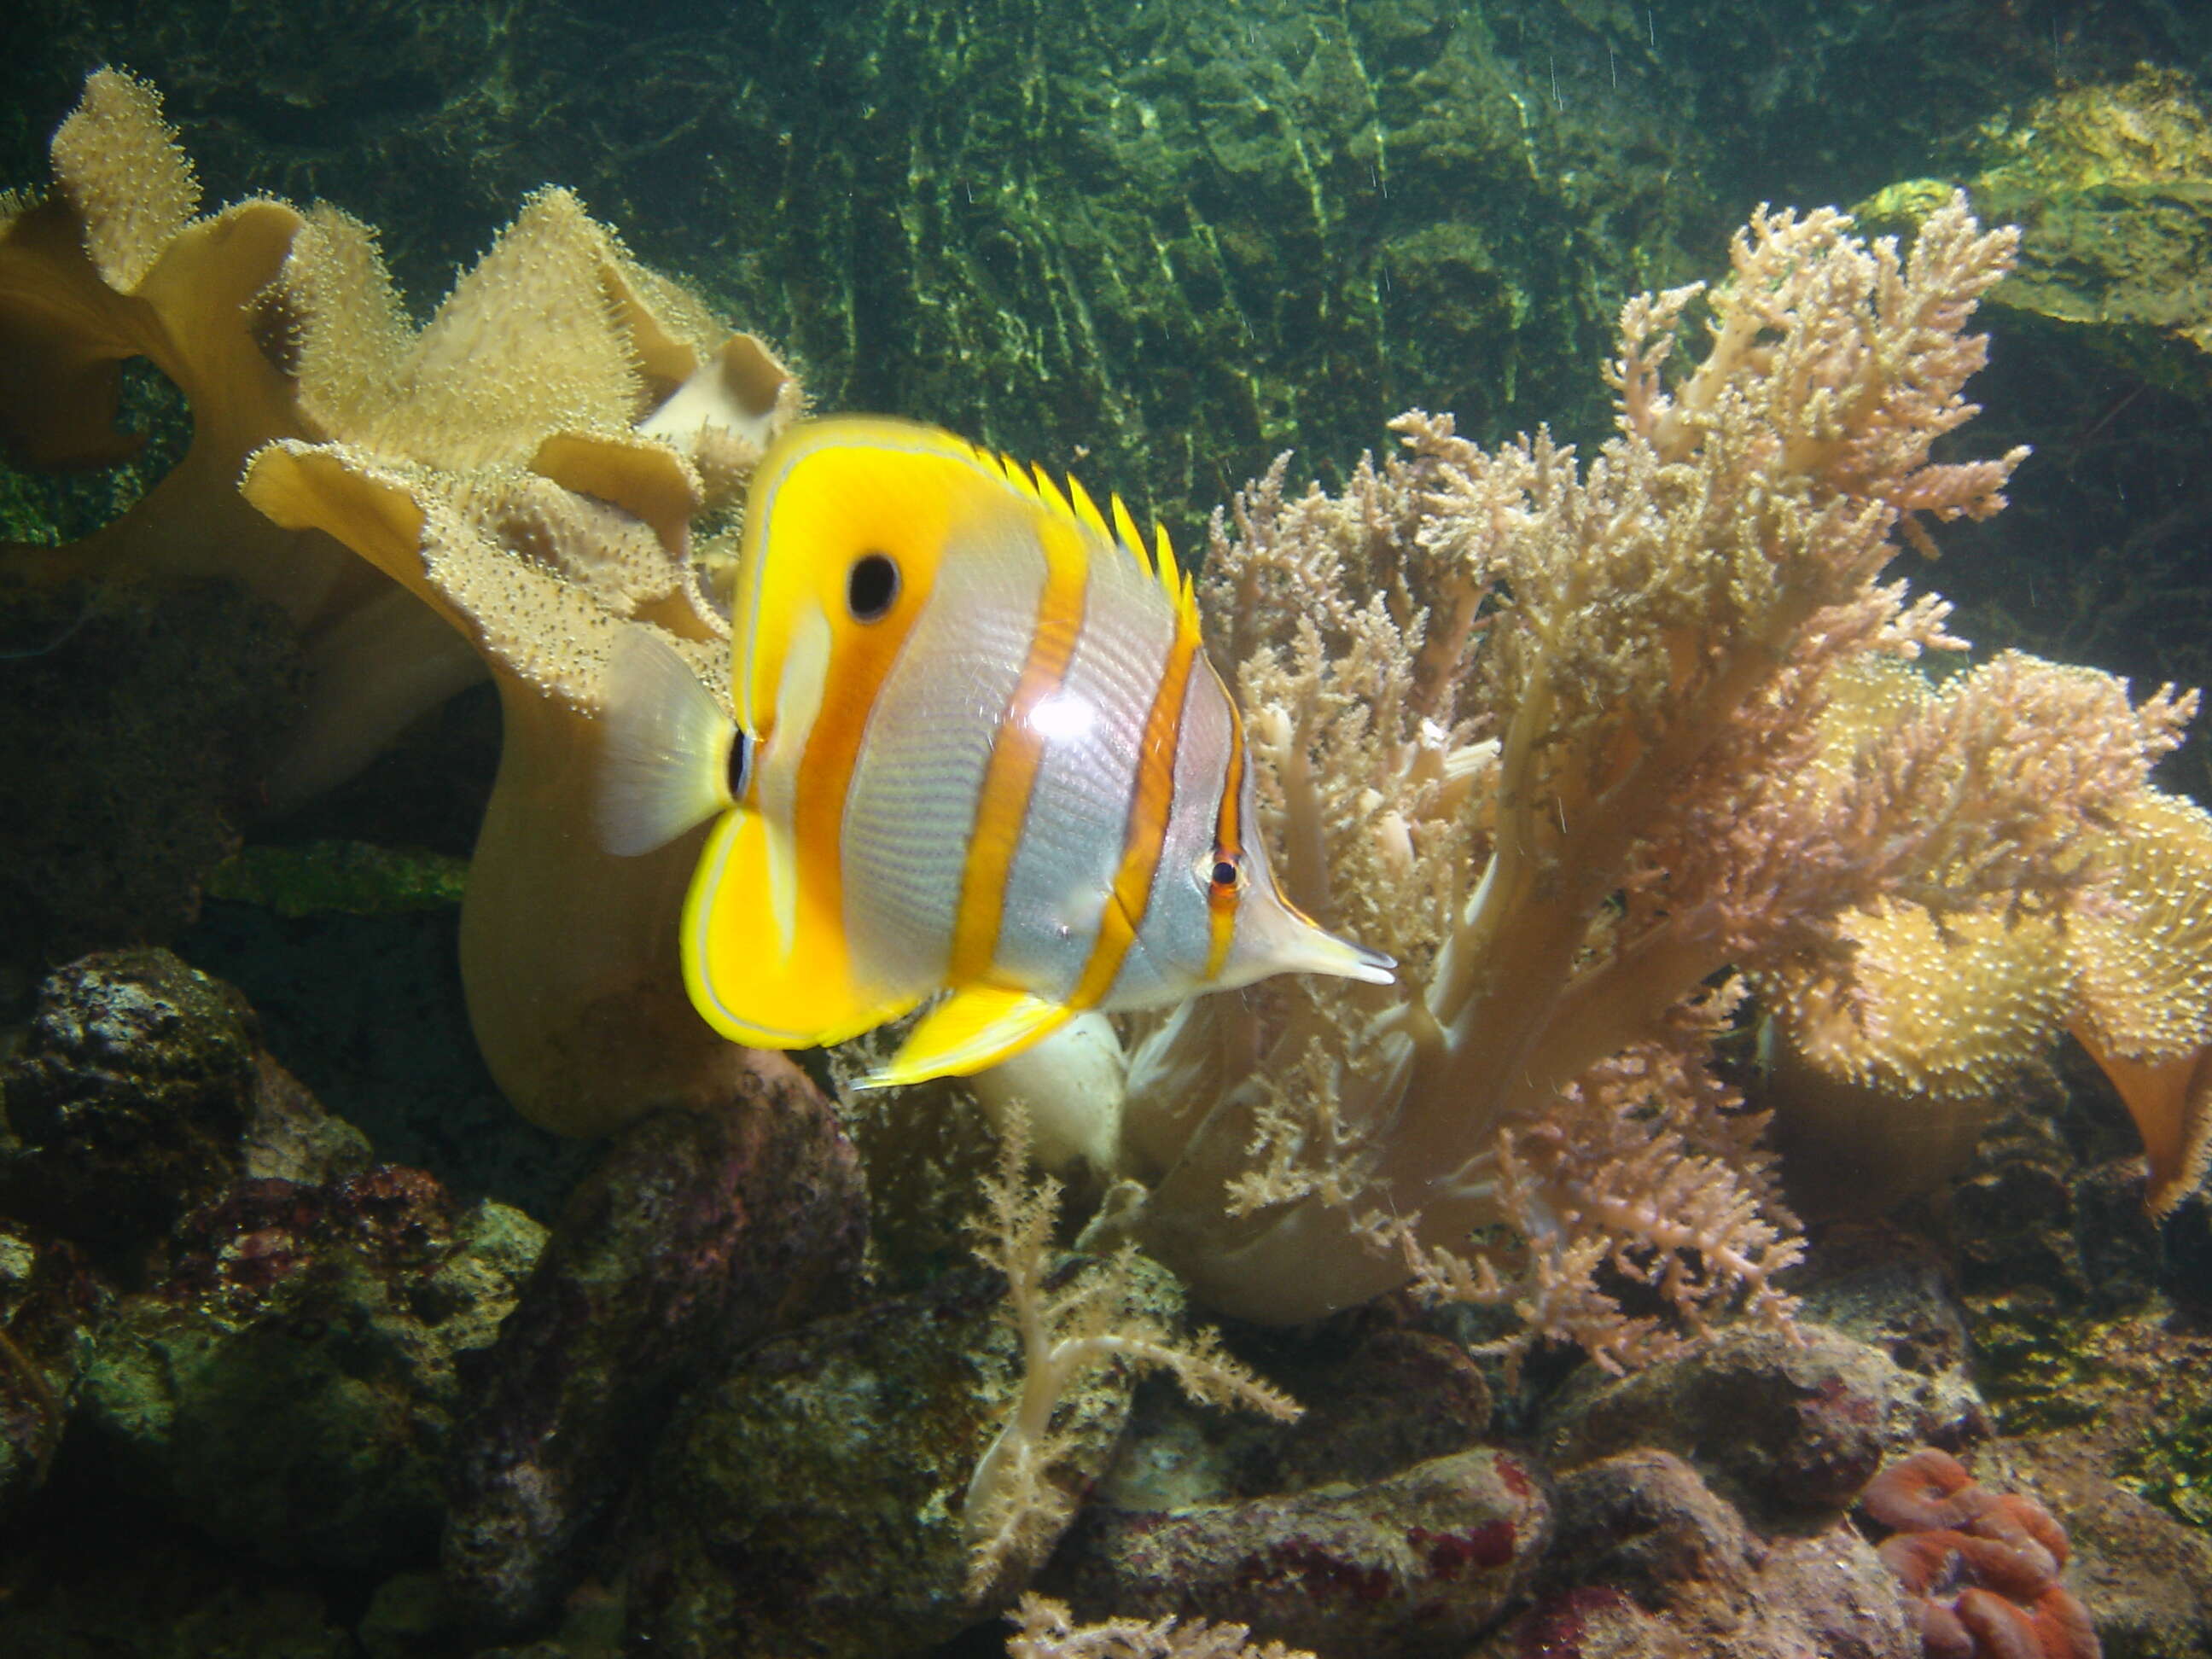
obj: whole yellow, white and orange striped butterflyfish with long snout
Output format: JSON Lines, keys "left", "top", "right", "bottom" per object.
{"left": 602, "top": 418, "right": 1391, "bottom": 1086}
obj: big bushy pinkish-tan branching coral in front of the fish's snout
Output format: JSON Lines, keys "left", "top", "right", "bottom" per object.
{"left": 995, "top": 201, "right": 2190, "bottom": 1363}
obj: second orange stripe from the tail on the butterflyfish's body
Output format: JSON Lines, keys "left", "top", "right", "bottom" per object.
{"left": 946, "top": 522, "right": 1091, "bottom": 984}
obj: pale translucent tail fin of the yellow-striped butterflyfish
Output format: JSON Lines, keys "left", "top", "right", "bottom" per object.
{"left": 593, "top": 626, "right": 736, "bottom": 859}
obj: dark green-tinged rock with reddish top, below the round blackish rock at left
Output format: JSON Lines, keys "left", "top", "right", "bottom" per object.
{"left": 84, "top": 1168, "right": 544, "bottom": 1573}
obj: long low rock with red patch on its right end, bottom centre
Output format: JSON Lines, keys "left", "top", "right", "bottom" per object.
{"left": 1042, "top": 1447, "right": 1551, "bottom": 1659}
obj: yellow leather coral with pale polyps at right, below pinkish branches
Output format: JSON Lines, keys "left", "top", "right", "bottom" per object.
{"left": 1763, "top": 703, "right": 2212, "bottom": 1214}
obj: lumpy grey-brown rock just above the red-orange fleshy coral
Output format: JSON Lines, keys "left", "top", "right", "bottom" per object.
{"left": 1540, "top": 1320, "right": 1980, "bottom": 1524}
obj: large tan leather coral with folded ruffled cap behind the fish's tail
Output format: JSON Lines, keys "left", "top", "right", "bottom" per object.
{"left": 0, "top": 71, "right": 803, "bottom": 1132}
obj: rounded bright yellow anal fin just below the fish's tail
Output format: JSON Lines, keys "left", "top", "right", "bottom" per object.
{"left": 684, "top": 810, "right": 920, "bottom": 1049}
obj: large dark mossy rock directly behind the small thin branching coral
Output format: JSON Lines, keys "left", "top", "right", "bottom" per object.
{"left": 626, "top": 1267, "right": 1132, "bottom": 1659}
